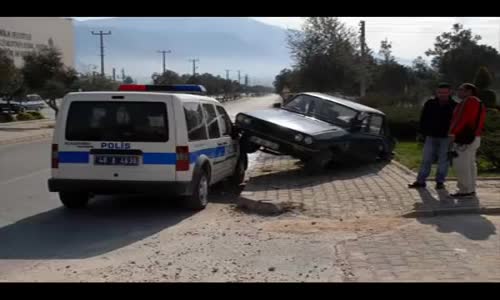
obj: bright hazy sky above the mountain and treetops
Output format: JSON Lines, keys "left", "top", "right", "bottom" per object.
{"left": 75, "top": 17, "right": 500, "bottom": 63}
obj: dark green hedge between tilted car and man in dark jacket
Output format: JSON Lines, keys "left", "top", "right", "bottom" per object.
{"left": 380, "top": 106, "right": 421, "bottom": 141}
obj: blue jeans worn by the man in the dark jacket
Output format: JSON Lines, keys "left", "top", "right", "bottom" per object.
{"left": 417, "top": 136, "right": 450, "bottom": 183}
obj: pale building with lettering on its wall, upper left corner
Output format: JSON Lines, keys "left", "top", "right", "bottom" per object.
{"left": 0, "top": 17, "right": 75, "bottom": 68}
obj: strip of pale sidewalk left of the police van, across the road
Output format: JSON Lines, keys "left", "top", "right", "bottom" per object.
{"left": 0, "top": 120, "right": 54, "bottom": 145}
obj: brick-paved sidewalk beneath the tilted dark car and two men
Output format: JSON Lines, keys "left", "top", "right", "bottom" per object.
{"left": 242, "top": 152, "right": 500, "bottom": 219}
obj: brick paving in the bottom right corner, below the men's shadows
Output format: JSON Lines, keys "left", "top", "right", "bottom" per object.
{"left": 336, "top": 215, "right": 500, "bottom": 282}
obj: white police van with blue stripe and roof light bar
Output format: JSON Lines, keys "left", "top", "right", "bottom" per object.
{"left": 48, "top": 85, "right": 247, "bottom": 209}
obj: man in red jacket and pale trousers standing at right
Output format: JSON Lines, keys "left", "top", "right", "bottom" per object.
{"left": 450, "top": 83, "right": 486, "bottom": 198}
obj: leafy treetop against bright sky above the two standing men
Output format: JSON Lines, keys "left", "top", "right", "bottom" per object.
{"left": 425, "top": 23, "right": 481, "bottom": 69}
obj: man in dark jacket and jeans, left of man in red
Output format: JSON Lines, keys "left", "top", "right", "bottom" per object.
{"left": 408, "top": 83, "right": 456, "bottom": 189}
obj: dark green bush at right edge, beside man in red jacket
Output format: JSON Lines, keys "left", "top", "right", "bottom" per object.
{"left": 479, "top": 109, "right": 500, "bottom": 170}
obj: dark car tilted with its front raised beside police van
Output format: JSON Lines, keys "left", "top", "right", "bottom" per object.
{"left": 236, "top": 93, "right": 395, "bottom": 168}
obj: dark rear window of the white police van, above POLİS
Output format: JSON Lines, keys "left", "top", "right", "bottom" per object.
{"left": 66, "top": 101, "right": 168, "bottom": 142}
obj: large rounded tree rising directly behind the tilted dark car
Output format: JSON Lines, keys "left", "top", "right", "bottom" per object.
{"left": 288, "top": 17, "right": 362, "bottom": 92}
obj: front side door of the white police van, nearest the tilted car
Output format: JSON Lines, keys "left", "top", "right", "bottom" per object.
{"left": 216, "top": 105, "right": 239, "bottom": 177}
